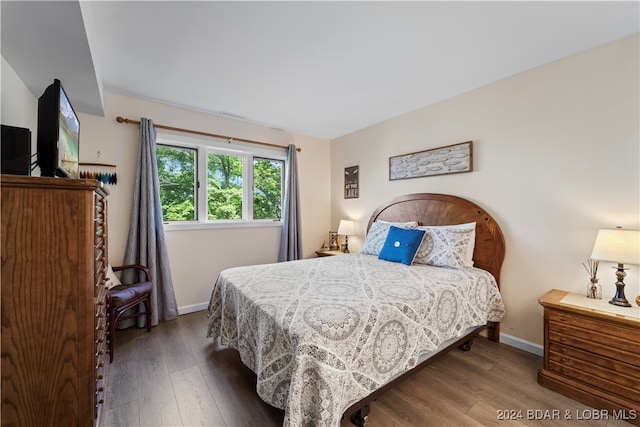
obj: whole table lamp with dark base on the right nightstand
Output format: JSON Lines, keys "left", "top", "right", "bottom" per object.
{"left": 591, "top": 227, "right": 640, "bottom": 307}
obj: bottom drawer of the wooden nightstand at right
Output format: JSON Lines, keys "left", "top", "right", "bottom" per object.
{"left": 549, "top": 354, "right": 640, "bottom": 404}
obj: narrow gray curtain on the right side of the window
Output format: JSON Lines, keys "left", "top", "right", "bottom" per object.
{"left": 278, "top": 144, "right": 302, "bottom": 262}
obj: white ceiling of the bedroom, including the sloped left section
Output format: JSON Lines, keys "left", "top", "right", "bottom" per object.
{"left": 2, "top": 0, "right": 640, "bottom": 139}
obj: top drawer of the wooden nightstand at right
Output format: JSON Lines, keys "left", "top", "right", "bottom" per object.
{"left": 548, "top": 311, "right": 640, "bottom": 344}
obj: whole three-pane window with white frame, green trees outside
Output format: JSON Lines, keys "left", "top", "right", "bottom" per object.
{"left": 156, "top": 135, "right": 286, "bottom": 229}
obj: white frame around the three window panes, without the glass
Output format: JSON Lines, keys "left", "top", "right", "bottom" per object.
{"left": 156, "top": 132, "right": 287, "bottom": 231}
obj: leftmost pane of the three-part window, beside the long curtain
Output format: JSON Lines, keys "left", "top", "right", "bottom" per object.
{"left": 156, "top": 145, "right": 196, "bottom": 221}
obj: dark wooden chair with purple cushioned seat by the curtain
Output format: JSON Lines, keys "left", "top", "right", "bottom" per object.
{"left": 107, "top": 264, "right": 153, "bottom": 363}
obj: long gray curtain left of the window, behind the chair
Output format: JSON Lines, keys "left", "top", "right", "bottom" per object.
{"left": 123, "top": 118, "right": 178, "bottom": 326}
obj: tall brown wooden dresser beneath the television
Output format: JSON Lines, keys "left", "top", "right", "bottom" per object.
{"left": 0, "top": 175, "right": 108, "bottom": 426}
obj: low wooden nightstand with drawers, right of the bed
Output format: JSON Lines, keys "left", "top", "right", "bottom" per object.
{"left": 538, "top": 290, "right": 640, "bottom": 425}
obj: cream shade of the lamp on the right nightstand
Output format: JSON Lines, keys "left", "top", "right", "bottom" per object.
{"left": 591, "top": 228, "right": 640, "bottom": 265}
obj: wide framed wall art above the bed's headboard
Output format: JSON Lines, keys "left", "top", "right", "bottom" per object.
{"left": 389, "top": 141, "right": 473, "bottom": 181}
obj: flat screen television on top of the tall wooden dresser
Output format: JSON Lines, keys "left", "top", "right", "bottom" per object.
{"left": 38, "top": 79, "right": 80, "bottom": 178}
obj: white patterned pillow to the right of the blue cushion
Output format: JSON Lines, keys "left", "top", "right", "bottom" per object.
{"left": 413, "top": 222, "right": 476, "bottom": 268}
